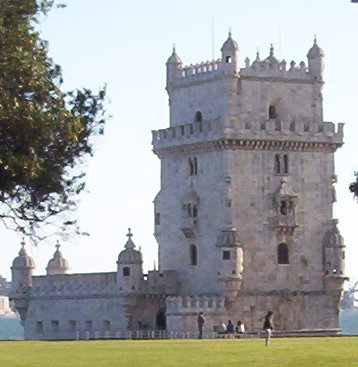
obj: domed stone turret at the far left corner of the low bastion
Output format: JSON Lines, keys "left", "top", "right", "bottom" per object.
{"left": 10, "top": 241, "right": 35, "bottom": 321}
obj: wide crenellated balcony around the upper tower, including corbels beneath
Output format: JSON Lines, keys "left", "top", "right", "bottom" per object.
{"left": 152, "top": 119, "right": 344, "bottom": 156}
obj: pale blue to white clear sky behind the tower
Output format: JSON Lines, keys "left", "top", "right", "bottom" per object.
{"left": 0, "top": 0, "right": 358, "bottom": 281}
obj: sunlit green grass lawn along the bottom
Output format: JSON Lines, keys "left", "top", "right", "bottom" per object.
{"left": 0, "top": 337, "right": 358, "bottom": 367}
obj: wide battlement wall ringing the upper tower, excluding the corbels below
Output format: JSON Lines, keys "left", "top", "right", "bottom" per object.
{"left": 152, "top": 119, "right": 344, "bottom": 151}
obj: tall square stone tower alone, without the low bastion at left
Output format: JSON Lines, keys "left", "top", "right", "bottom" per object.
{"left": 153, "top": 33, "right": 346, "bottom": 333}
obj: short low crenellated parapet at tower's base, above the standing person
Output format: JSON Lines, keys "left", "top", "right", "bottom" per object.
{"left": 165, "top": 296, "right": 227, "bottom": 315}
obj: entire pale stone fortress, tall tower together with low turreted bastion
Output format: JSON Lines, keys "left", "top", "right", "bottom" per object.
{"left": 10, "top": 33, "right": 347, "bottom": 339}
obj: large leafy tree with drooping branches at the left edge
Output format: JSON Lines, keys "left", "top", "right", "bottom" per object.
{"left": 0, "top": 0, "right": 105, "bottom": 246}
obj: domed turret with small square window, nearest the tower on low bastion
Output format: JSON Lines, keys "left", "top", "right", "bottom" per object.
{"left": 117, "top": 228, "right": 143, "bottom": 293}
